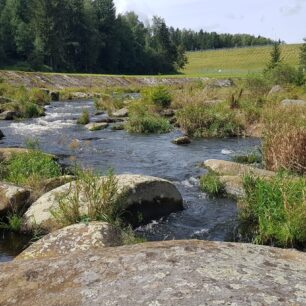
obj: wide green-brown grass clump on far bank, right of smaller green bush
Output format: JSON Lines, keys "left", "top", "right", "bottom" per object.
{"left": 176, "top": 104, "right": 243, "bottom": 137}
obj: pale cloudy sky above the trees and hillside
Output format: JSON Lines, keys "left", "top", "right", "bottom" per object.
{"left": 114, "top": 0, "right": 306, "bottom": 43}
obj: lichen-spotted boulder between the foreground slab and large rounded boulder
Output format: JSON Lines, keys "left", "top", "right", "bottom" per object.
{"left": 17, "top": 222, "right": 121, "bottom": 260}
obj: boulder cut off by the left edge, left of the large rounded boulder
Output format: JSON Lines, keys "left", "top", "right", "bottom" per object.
{"left": 0, "top": 182, "right": 31, "bottom": 216}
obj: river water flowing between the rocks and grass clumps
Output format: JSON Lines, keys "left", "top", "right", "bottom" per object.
{"left": 0, "top": 101, "right": 259, "bottom": 261}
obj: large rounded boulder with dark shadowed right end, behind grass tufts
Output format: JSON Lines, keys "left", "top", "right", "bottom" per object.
{"left": 23, "top": 174, "right": 183, "bottom": 231}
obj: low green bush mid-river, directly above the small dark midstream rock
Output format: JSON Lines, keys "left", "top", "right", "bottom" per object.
{"left": 125, "top": 113, "right": 172, "bottom": 134}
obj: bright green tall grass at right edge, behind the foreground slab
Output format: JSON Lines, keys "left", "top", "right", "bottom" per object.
{"left": 239, "top": 175, "right": 306, "bottom": 248}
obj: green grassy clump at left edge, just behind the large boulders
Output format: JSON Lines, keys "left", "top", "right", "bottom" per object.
{"left": 4, "top": 150, "right": 61, "bottom": 186}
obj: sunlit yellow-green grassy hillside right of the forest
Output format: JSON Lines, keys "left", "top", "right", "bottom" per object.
{"left": 182, "top": 45, "right": 301, "bottom": 77}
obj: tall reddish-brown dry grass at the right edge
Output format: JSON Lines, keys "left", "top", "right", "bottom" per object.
{"left": 263, "top": 106, "right": 306, "bottom": 174}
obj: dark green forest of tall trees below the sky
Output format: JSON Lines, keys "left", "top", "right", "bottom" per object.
{"left": 0, "top": 0, "right": 272, "bottom": 74}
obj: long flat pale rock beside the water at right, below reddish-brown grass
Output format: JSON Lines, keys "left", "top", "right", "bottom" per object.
{"left": 204, "top": 159, "right": 276, "bottom": 177}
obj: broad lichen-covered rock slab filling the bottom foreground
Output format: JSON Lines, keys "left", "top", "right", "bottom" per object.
{"left": 0, "top": 240, "right": 306, "bottom": 306}
